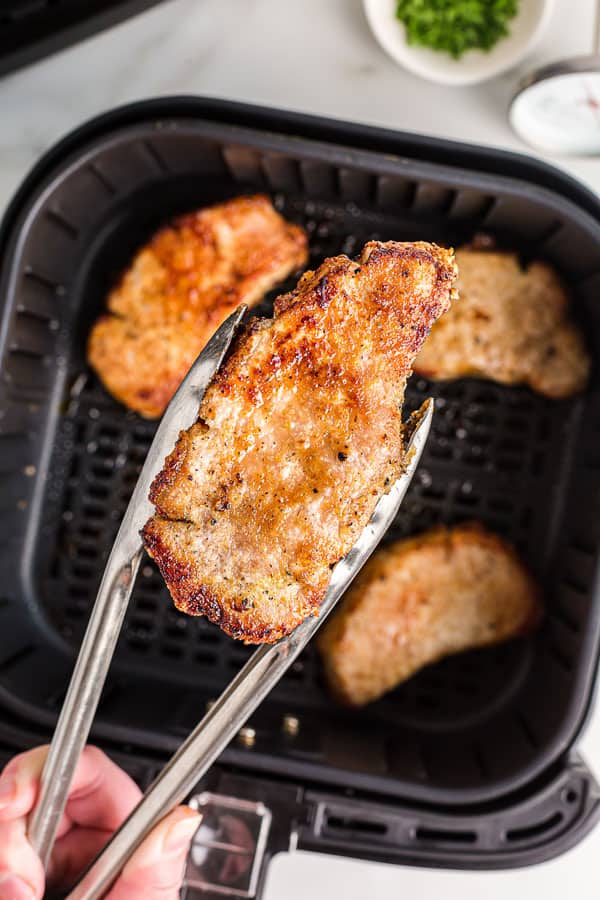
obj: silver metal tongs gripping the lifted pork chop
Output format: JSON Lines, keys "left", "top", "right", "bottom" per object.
{"left": 29, "top": 306, "right": 433, "bottom": 900}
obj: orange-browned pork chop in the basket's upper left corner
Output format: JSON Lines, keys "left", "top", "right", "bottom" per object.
{"left": 88, "top": 195, "right": 307, "bottom": 418}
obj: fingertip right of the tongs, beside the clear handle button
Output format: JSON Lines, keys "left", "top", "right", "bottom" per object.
{"left": 106, "top": 806, "right": 201, "bottom": 900}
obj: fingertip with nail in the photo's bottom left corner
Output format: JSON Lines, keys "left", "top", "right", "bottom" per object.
{"left": 0, "top": 819, "right": 44, "bottom": 900}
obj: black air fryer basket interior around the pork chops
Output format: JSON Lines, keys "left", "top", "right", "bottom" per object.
{"left": 0, "top": 100, "right": 600, "bottom": 820}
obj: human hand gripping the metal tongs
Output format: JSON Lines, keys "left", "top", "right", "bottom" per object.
{"left": 0, "top": 746, "right": 200, "bottom": 900}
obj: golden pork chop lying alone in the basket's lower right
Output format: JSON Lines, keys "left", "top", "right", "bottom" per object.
{"left": 317, "top": 523, "right": 541, "bottom": 706}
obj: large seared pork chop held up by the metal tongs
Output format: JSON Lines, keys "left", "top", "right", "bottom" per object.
{"left": 143, "top": 242, "right": 456, "bottom": 643}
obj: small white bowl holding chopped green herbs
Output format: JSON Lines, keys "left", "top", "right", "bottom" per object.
{"left": 363, "top": 0, "right": 554, "bottom": 85}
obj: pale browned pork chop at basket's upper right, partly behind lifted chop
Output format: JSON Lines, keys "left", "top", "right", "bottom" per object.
{"left": 414, "top": 249, "right": 590, "bottom": 398}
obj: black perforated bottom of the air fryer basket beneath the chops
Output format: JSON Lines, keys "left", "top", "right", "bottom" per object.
{"left": 38, "top": 196, "right": 575, "bottom": 729}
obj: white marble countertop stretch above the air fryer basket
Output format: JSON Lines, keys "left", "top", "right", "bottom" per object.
{"left": 0, "top": 0, "right": 600, "bottom": 205}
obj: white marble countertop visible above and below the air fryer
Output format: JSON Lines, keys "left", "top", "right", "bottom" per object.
{"left": 0, "top": 0, "right": 600, "bottom": 900}
